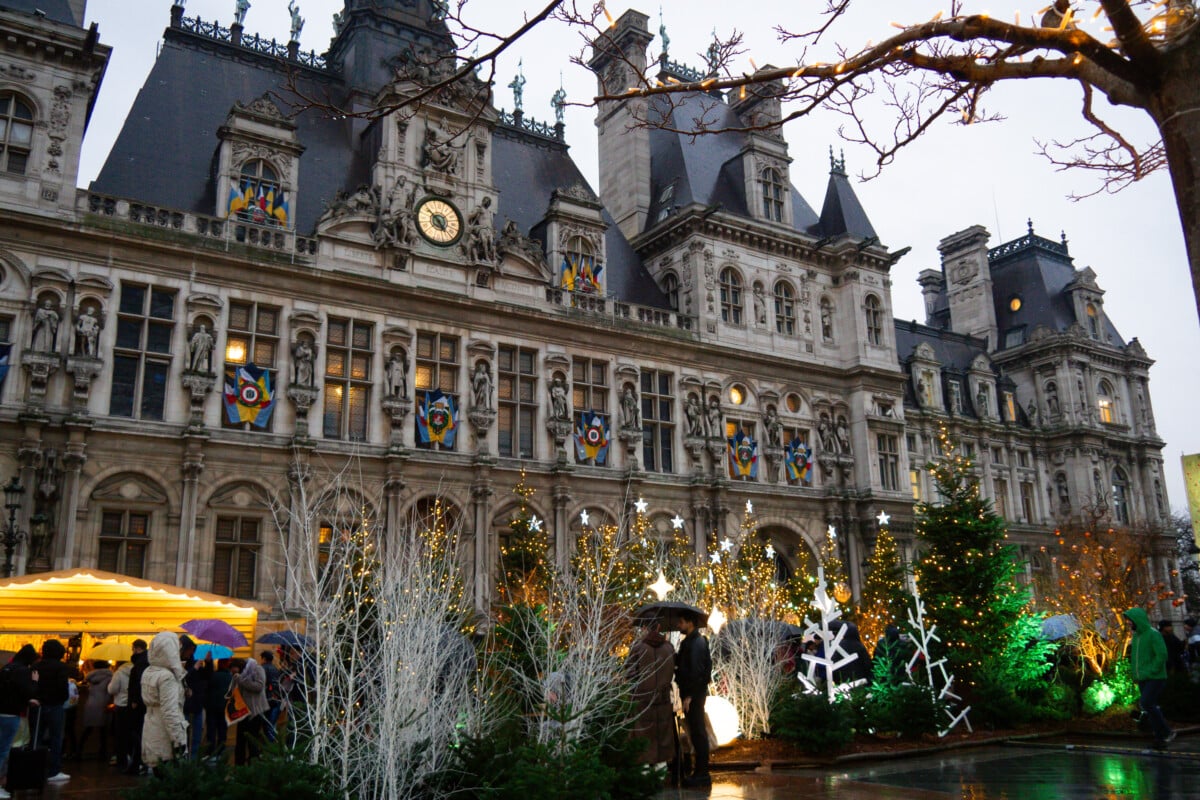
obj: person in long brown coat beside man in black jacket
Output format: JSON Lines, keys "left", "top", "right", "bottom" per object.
{"left": 625, "top": 622, "right": 676, "bottom": 764}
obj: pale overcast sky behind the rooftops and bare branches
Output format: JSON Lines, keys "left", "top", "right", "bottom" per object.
{"left": 79, "top": 0, "right": 1200, "bottom": 510}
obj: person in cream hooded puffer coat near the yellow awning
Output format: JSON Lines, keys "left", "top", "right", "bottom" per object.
{"left": 142, "top": 631, "right": 187, "bottom": 768}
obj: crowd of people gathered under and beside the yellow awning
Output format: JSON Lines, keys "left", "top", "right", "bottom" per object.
{"left": 0, "top": 631, "right": 299, "bottom": 800}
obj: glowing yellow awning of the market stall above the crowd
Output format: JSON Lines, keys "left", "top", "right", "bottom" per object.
{"left": 0, "top": 569, "right": 270, "bottom": 642}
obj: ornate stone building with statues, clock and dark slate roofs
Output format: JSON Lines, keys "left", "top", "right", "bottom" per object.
{"left": 0, "top": 0, "right": 1166, "bottom": 604}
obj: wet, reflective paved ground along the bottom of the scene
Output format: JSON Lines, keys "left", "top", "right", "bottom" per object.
{"left": 16, "top": 735, "right": 1200, "bottom": 800}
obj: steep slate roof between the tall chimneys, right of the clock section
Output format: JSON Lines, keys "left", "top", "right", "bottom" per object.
{"left": 647, "top": 92, "right": 817, "bottom": 231}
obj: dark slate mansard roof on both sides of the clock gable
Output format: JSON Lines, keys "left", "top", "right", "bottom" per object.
{"left": 91, "top": 16, "right": 668, "bottom": 308}
